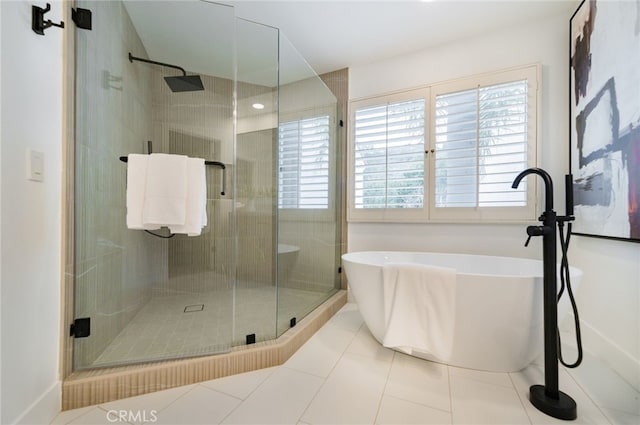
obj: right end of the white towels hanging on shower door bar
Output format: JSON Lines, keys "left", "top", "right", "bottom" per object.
{"left": 169, "top": 158, "right": 207, "bottom": 236}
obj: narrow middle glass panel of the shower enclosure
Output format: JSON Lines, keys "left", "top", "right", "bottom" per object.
{"left": 234, "top": 19, "right": 278, "bottom": 345}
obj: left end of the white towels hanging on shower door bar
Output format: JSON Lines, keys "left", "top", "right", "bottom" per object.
{"left": 127, "top": 154, "right": 160, "bottom": 230}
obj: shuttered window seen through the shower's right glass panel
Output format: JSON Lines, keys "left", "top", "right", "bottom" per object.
{"left": 278, "top": 115, "right": 330, "bottom": 209}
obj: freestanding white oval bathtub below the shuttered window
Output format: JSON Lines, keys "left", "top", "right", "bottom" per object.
{"left": 342, "top": 251, "right": 582, "bottom": 372}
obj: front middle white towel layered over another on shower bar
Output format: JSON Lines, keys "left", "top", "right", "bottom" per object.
{"left": 142, "top": 153, "right": 187, "bottom": 226}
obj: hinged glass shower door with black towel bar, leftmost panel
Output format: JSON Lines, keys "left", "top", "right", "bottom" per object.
{"left": 74, "top": 0, "right": 236, "bottom": 370}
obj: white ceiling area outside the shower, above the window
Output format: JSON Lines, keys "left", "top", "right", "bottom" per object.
{"left": 228, "top": 0, "right": 579, "bottom": 74}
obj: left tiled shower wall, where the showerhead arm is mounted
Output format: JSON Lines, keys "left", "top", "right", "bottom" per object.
{"left": 74, "top": 1, "right": 167, "bottom": 368}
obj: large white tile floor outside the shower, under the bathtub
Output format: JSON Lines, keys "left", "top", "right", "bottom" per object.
{"left": 52, "top": 304, "right": 640, "bottom": 425}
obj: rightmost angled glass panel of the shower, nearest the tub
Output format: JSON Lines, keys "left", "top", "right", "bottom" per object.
{"left": 277, "top": 34, "right": 342, "bottom": 336}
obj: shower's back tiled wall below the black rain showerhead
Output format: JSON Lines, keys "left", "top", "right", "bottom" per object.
{"left": 151, "top": 73, "right": 234, "bottom": 295}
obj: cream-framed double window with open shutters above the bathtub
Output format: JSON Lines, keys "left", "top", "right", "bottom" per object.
{"left": 349, "top": 65, "right": 539, "bottom": 221}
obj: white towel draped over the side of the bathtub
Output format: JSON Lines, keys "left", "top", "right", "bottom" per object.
{"left": 382, "top": 263, "right": 456, "bottom": 361}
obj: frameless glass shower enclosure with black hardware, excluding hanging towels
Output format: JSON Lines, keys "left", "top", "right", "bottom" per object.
{"left": 73, "top": 0, "right": 341, "bottom": 370}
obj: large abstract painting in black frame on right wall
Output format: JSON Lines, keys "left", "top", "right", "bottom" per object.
{"left": 570, "top": 0, "right": 640, "bottom": 242}
